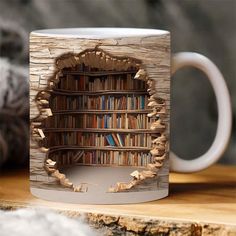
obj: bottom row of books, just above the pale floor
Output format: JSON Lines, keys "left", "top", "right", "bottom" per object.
{"left": 50, "top": 150, "right": 153, "bottom": 166}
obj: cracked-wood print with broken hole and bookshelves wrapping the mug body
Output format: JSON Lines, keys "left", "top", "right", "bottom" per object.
{"left": 30, "top": 30, "right": 169, "bottom": 204}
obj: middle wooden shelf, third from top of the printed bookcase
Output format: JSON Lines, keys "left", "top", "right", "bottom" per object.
{"left": 52, "top": 109, "right": 152, "bottom": 115}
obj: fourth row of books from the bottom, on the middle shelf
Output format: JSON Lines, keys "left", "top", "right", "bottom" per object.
{"left": 50, "top": 94, "right": 148, "bottom": 110}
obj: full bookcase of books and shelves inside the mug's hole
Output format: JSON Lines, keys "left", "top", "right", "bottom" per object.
{"left": 42, "top": 63, "right": 158, "bottom": 168}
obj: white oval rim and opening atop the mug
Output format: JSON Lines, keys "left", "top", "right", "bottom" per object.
{"left": 31, "top": 27, "right": 170, "bottom": 39}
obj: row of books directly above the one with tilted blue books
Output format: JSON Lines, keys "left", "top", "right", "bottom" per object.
{"left": 45, "top": 113, "right": 151, "bottom": 129}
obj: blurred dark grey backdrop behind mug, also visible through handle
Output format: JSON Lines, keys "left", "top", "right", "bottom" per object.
{"left": 0, "top": 0, "right": 236, "bottom": 164}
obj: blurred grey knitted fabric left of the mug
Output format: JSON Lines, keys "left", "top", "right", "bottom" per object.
{"left": 0, "top": 25, "right": 29, "bottom": 167}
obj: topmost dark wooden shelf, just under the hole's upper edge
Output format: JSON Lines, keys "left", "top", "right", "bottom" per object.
{"left": 62, "top": 70, "right": 137, "bottom": 76}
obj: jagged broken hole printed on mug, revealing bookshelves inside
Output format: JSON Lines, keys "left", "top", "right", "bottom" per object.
{"left": 36, "top": 49, "right": 166, "bottom": 192}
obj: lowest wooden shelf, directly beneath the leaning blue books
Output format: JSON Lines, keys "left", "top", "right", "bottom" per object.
{"left": 49, "top": 145, "right": 151, "bottom": 152}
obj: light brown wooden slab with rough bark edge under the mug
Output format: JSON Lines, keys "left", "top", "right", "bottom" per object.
{"left": 0, "top": 165, "right": 236, "bottom": 236}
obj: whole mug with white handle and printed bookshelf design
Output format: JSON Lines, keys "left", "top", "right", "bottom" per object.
{"left": 30, "top": 28, "right": 232, "bottom": 204}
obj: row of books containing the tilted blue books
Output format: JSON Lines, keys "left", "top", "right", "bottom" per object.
{"left": 45, "top": 132, "right": 151, "bottom": 149}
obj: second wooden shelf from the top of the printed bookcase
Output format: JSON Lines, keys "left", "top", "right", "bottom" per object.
{"left": 50, "top": 89, "right": 149, "bottom": 96}
